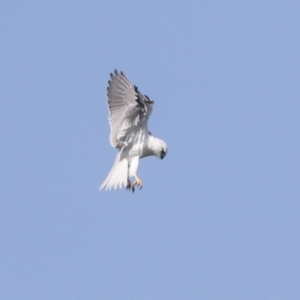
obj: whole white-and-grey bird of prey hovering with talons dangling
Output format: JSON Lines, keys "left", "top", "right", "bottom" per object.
{"left": 100, "top": 70, "right": 168, "bottom": 192}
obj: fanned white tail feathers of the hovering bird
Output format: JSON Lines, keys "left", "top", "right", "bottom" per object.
{"left": 99, "top": 152, "right": 128, "bottom": 191}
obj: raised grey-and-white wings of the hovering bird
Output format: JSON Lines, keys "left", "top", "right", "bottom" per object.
{"left": 107, "top": 70, "right": 154, "bottom": 148}
